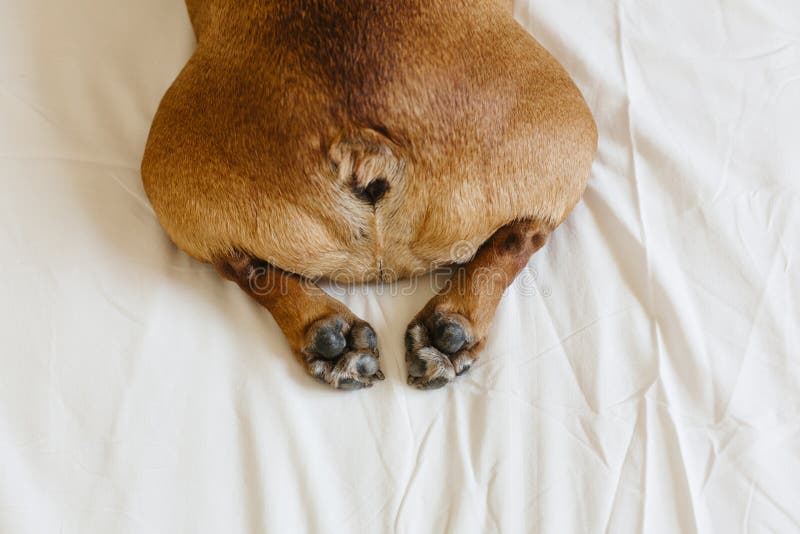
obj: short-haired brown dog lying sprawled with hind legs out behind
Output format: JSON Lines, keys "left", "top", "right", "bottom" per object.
{"left": 142, "top": 0, "right": 597, "bottom": 389}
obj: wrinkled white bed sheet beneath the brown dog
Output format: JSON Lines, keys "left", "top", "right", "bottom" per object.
{"left": 0, "top": 0, "right": 800, "bottom": 534}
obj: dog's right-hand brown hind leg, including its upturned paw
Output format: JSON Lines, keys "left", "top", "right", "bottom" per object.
{"left": 406, "top": 220, "right": 553, "bottom": 389}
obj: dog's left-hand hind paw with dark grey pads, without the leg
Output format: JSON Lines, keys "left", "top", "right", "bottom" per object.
{"left": 301, "top": 314, "right": 384, "bottom": 390}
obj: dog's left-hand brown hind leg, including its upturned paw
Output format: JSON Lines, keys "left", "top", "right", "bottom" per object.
{"left": 215, "top": 252, "right": 383, "bottom": 389}
